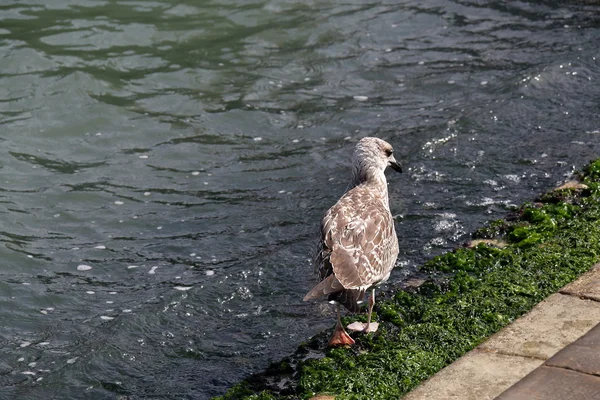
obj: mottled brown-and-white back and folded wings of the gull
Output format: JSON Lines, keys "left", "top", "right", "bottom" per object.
{"left": 322, "top": 195, "right": 398, "bottom": 289}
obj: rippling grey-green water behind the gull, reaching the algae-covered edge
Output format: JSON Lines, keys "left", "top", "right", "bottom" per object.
{"left": 0, "top": 0, "right": 600, "bottom": 399}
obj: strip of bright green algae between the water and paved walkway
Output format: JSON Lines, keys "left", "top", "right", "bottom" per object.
{"left": 221, "top": 159, "right": 600, "bottom": 400}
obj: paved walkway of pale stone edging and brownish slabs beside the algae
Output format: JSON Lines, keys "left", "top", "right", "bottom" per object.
{"left": 404, "top": 264, "right": 600, "bottom": 400}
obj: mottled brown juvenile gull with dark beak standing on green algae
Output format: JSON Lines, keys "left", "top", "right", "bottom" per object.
{"left": 304, "top": 137, "right": 402, "bottom": 346}
